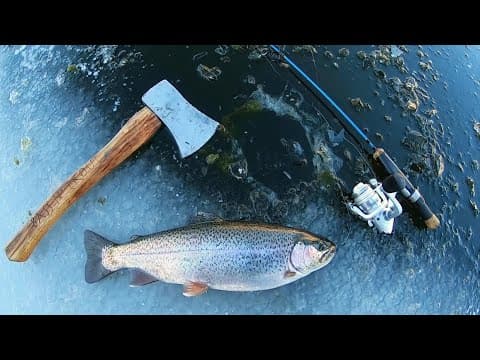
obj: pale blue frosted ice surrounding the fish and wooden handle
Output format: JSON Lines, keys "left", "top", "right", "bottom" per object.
{"left": 0, "top": 46, "right": 480, "bottom": 314}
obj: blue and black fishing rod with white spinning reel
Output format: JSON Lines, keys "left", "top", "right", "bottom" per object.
{"left": 270, "top": 45, "right": 440, "bottom": 234}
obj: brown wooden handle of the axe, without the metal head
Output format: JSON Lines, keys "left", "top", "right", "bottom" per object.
{"left": 5, "top": 107, "right": 162, "bottom": 261}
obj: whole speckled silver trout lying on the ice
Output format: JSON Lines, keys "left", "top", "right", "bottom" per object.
{"left": 84, "top": 216, "right": 336, "bottom": 296}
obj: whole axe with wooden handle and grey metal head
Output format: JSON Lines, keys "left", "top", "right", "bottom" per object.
{"left": 5, "top": 80, "right": 218, "bottom": 261}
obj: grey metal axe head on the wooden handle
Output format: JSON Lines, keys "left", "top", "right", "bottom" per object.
{"left": 142, "top": 80, "right": 218, "bottom": 159}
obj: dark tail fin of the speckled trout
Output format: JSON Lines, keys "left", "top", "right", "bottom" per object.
{"left": 84, "top": 230, "right": 115, "bottom": 284}
